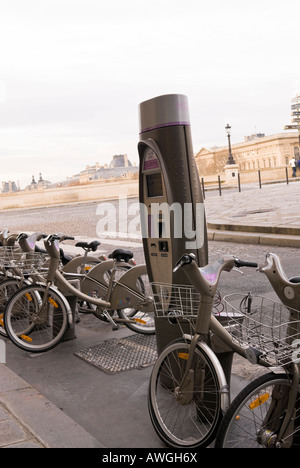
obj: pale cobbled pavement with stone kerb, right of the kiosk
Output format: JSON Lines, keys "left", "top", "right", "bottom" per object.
{"left": 205, "top": 181, "right": 300, "bottom": 247}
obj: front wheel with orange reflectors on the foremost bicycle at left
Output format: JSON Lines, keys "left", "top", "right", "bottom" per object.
{"left": 4, "top": 285, "right": 68, "bottom": 352}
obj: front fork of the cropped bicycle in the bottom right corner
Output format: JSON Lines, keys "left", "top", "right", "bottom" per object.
{"left": 257, "top": 364, "right": 299, "bottom": 448}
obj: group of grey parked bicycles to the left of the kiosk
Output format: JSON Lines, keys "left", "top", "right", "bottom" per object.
{"left": 0, "top": 229, "right": 155, "bottom": 352}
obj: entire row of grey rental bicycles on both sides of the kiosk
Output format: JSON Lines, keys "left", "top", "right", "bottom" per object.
{"left": 0, "top": 225, "right": 300, "bottom": 449}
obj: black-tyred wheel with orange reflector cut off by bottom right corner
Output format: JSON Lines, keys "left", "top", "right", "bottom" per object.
{"left": 215, "top": 373, "right": 300, "bottom": 448}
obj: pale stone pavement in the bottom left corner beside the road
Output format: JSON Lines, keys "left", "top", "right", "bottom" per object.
{"left": 0, "top": 364, "right": 103, "bottom": 448}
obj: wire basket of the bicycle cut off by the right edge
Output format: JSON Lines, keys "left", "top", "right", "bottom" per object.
{"left": 223, "top": 293, "right": 300, "bottom": 366}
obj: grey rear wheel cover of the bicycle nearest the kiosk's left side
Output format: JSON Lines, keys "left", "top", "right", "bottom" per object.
{"left": 111, "top": 265, "right": 153, "bottom": 311}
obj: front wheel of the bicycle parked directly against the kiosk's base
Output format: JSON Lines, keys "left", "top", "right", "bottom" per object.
{"left": 148, "top": 339, "right": 222, "bottom": 449}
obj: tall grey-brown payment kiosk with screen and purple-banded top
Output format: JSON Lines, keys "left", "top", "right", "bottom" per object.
{"left": 138, "top": 94, "right": 208, "bottom": 351}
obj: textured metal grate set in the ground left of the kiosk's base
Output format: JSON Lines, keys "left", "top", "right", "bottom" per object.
{"left": 74, "top": 335, "right": 157, "bottom": 374}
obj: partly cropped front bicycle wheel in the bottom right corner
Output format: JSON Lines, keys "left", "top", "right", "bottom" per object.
{"left": 215, "top": 373, "right": 300, "bottom": 448}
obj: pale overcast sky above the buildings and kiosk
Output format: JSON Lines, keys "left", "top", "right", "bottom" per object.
{"left": 0, "top": 0, "right": 300, "bottom": 188}
